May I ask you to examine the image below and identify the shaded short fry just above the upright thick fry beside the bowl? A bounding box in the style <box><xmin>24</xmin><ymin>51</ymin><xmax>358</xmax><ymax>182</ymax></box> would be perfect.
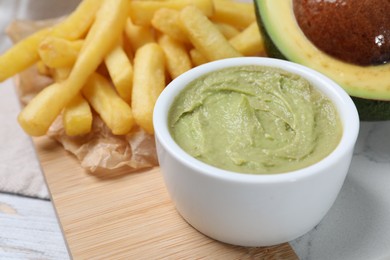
<box><xmin>125</xmin><ymin>17</ymin><xmax>155</xmax><ymax>52</ymax></box>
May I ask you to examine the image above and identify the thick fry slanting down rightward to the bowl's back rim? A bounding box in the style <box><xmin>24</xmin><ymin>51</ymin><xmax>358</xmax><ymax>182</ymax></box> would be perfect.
<box><xmin>180</xmin><ymin>5</ymin><xmax>242</xmax><ymax>61</ymax></box>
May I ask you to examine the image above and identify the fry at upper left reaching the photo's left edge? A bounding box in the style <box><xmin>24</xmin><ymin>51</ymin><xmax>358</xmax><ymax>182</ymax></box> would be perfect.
<box><xmin>0</xmin><ymin>0</ymin><xmax>103</xmax><ymax>82</ymax></box>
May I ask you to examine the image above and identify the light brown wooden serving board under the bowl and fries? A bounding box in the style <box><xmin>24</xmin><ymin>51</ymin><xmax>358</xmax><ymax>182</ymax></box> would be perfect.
<box><xmin>33</xmin><ymin>137</ymin><xmax>298</xmax><ymax>259</ymax></box>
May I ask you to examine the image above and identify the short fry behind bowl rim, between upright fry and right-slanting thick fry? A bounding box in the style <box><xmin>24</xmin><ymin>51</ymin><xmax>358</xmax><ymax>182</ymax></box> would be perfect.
<box><xmin>158</xmin><ymin>34</ymin><xmax>192</xmax><ymax>79</ymax></box>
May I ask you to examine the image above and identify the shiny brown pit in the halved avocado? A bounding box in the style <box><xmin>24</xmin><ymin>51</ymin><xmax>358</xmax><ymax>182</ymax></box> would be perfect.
<box><xmin>293</xmin><ymin>0</ymin><xmax>390</xmax><ymax>66</ymax></box>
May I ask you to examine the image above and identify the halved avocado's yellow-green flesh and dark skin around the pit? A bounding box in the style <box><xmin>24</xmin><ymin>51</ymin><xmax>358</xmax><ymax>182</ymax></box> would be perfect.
<box><xmin>254</xmin><ymin>0</ymin><xmax>390</xmax><ymax>121</ymax></box>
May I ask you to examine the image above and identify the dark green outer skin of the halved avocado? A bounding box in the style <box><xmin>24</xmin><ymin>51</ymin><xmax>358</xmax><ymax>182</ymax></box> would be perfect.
<box><xmin>254</xmin><ymin>0</ymin><xmax>390</xmax><ymax>121</ymax></box>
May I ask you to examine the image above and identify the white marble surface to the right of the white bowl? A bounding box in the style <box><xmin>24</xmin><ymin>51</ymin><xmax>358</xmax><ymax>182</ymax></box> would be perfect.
<box><xmin>291</xmin><ymin>121</ymin><xmax>390</xmax><ymax>260</ymax></box>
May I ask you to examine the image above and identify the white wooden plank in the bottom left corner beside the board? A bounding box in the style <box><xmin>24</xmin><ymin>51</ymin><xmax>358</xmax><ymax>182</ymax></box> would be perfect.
<box><xmin>0</xmin><ymin>193</ymin><xmax>70</xmax><ymax>260</ymax></box>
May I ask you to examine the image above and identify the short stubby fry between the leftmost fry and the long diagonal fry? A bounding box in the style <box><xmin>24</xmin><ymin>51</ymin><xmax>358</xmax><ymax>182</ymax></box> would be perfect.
<box><xmin>38</xmin><ymin>36</ymin><xmax>84</xmax><ymax>68</ymax></box>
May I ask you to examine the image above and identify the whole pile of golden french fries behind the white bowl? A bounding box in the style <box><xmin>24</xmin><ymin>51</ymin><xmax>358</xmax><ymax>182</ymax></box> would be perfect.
<box><xmin>0</xmin><ymin>0</ymin><xmax>264</xmax><ymax>136</ymax></box>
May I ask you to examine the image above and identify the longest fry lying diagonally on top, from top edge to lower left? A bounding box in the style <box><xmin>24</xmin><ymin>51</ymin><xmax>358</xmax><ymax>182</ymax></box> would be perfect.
<box><xmin>18</xmin><ymin>0</ymin><xmax>129</xmax><ymax>136</ymax></box>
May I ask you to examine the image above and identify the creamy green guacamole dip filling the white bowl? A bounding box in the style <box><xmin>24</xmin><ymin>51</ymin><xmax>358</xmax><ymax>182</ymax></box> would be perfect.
<box><xmin>168</xmin><ymin>66</ymin><xmax>342</xmax><ymax>174</ymax></box>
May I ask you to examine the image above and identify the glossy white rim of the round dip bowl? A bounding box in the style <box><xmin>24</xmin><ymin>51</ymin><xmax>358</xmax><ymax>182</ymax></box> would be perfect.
<box><xmin>153</xmin><ymin>57</ymin><xmax>360</xmax><ymax>183</ymax></box>
